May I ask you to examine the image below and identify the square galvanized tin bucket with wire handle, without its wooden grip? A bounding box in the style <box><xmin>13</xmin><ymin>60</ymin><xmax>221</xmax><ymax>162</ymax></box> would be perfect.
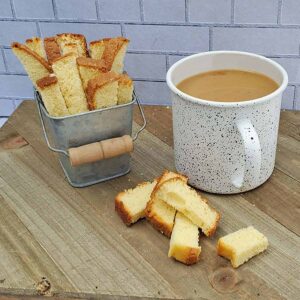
<box><xmin>35</xmin><ymin>91</ymin><xmax>146</xmax><ymax>187</ymax></box>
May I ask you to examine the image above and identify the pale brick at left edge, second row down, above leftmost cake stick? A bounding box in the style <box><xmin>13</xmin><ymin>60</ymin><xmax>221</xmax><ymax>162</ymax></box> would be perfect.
<box><xmin>0</xmin><ymin>21</ymin><xmax>37</xmax><ymax>46</ymax></box>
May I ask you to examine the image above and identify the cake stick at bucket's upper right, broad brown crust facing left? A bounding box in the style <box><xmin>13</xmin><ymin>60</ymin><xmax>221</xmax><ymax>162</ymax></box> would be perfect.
<box><xmin>102</xmin><ymin>37</ymin><xmax>129</xmax><ymax>73</ymax></box>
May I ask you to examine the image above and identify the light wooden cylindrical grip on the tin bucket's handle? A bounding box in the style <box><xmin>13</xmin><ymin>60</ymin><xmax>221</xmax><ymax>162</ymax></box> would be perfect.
<box><xmin>69</xmin><ymin>135</ymin><xmax>133</xmax><ymax>166</ymax></box>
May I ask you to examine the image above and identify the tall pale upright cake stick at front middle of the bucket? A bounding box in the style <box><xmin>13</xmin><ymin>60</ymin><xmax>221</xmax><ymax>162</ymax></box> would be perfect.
<box><xmin>52</xmin><ymin>53</ymin><xmax>88</xmax><ymax>114</ymax></box>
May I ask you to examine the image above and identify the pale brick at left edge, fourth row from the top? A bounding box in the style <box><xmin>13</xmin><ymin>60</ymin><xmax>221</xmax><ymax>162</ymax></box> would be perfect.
<box><xmin>0</xmin><ymin>75</ymin><xmax>33</xmax><ymax>99</ymax></box>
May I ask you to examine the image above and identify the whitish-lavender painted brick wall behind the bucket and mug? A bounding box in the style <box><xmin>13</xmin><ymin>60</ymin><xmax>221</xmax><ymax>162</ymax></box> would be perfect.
<box><xmin>0</xmin><ymin>0</ymin><xmax>300</xmax><ymax>122</ymax></box>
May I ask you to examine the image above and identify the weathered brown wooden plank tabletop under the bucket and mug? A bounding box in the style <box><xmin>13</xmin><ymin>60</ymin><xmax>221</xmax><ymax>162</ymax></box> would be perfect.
<box><xmin>0</xmin><ymin>101</ymin><xmax>300</xmax><ymax>299</ymax></box>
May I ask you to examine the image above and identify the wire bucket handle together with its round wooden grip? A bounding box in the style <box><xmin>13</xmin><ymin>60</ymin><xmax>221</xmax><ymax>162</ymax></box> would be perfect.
<box><xmin>35</xmin><ymin>90</ymin><xmax>147</xmax><ymax>166</ymax></box>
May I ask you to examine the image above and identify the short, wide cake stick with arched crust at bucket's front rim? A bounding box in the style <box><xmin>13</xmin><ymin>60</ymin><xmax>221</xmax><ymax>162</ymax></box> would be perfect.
<box><xmin>86</xmin><ymin>72</ymin><xmax>119</xmax><ymax>110</ymax></box>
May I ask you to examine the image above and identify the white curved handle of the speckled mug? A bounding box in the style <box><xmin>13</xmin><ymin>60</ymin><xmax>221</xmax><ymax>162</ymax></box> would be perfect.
<box><xmin>231</xmin><ymin>119</ymin><xmax>261</xmax><ymax>189</ymax></box>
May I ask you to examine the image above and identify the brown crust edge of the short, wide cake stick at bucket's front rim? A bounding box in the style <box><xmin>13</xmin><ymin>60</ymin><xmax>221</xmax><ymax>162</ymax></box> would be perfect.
<box><xmin>86</xmin><ymin>72</ymin><xmax>120</xmax><ymax>110</ymax></box>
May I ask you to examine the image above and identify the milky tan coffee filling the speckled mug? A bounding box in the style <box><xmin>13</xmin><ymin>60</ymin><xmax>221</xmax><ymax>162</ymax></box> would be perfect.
<box><xmin>177</xmin><ymin>70</ymin><xmax>278</xmax><ymax>102</ymax></box>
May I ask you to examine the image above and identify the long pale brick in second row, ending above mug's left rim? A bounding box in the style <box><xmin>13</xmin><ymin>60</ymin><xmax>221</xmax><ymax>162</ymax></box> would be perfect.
<box><xmin>125</xmin><ymin>25</ymin><xmax>208</xmax><ymax>53</ymax></box>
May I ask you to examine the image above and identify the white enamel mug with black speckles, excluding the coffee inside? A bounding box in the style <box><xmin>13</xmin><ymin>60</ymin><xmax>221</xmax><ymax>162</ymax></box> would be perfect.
<box><xmin>167</xmin><ymin>51</ymin><xmax>288</xmax><ymax>194</ymax></box>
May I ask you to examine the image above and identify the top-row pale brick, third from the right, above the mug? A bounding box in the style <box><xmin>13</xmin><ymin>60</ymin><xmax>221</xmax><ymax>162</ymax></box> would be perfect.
<box><xmin>189</xmin><ymin>0</ymin><xmax>231</xmax><ymax>23</ymax></box>
